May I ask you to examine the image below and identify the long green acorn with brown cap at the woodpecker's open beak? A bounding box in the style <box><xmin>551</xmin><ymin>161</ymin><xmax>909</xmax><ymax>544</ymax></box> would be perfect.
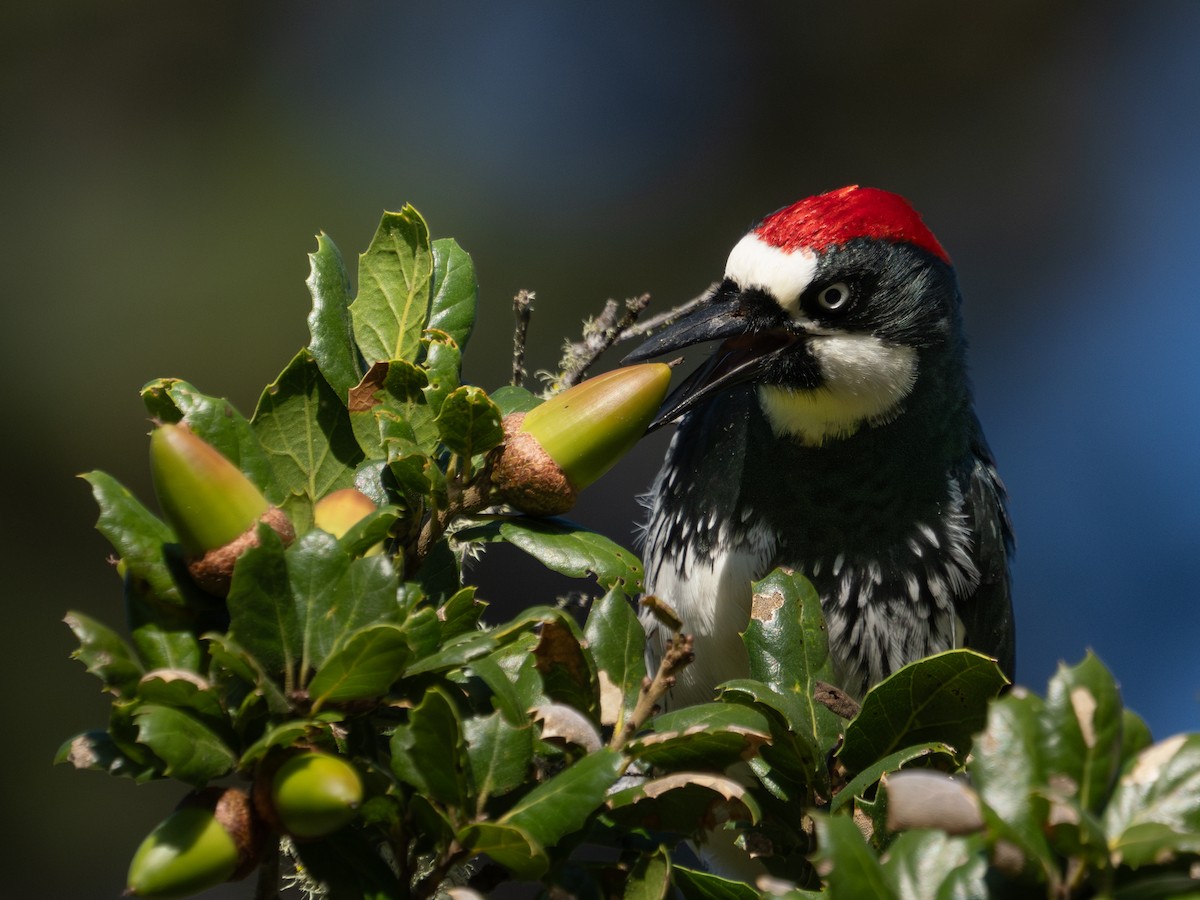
<box><xmin>492</xmin><ymin>362</ymin><xmax>671</xmax><ymax>516</ymax></box>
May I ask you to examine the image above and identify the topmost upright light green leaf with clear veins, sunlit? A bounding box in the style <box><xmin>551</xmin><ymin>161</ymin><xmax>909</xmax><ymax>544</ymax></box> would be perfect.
<box><xmin>350</xmin><ymin>205</ymin><xmax>433</xmax><ymax>365</ymax></box>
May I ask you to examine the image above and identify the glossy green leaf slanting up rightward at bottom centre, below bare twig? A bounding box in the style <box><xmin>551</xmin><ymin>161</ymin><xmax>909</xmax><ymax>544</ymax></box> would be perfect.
<box><xmin>498</xmin><ymin>748</ymin><xmax>624</xmax><ymax>847</ymax></box>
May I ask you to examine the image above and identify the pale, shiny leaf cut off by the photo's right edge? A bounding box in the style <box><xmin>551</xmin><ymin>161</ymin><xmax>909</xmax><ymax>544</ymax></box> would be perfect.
<box><xmin>1104</xmin><ymin>734</ymin><xmax>1200</xmax><ymax>866</ymax></box>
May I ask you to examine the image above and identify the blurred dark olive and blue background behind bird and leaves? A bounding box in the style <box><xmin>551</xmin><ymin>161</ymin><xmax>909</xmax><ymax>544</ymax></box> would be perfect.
<box><xmin>0</xmin><ymin>0</ymin><xmax>1200</xmax><ymax>900</ymax></box>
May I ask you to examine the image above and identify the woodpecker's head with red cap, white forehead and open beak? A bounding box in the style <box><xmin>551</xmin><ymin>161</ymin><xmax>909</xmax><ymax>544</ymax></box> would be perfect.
<box><xmin>625</xmin><ymin>186</ymin><xmax>962</xmax><ymax>444</ymax></box>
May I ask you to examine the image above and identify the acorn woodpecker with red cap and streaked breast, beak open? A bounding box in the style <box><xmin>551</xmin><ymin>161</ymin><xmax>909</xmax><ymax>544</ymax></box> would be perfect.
<box><xmin>625</xmin><ymin>186</ymin><xmax>1014</xmax><ymax>706</ymax></box>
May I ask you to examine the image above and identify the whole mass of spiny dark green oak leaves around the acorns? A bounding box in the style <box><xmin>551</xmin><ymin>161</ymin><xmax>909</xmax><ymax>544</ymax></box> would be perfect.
<box><xmin>59</xmin><ymin>208</ymin><xmax>1200</xmax><ymax>900</ymax></box>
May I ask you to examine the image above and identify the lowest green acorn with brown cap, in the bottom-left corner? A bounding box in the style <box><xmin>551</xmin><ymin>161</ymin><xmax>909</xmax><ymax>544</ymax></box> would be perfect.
<box><xmin>126</xmin><ymin>787</ymin><xmax>263</xmax><ymax>899</ymax></box>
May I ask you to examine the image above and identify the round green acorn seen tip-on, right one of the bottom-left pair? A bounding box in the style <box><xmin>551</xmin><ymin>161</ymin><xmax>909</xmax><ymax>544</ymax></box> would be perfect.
<box><xmin>262</xmin><ymin>750</ymin><xmax>362</xmax><ymax>840</ymax></box>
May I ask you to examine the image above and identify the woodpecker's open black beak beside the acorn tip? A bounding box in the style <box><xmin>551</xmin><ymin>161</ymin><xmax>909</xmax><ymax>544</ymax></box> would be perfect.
<box><xmin>622</xmin><ymin>290</ymin><xmax>803</xmax><ymax>431</ymax></box>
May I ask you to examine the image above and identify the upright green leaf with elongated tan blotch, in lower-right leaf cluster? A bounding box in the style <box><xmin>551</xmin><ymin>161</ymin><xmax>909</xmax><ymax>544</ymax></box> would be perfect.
<box><xmin>1044</xmin><ymin>652</ymin><xmax>1123</xmax><ymax>812</ymax></box>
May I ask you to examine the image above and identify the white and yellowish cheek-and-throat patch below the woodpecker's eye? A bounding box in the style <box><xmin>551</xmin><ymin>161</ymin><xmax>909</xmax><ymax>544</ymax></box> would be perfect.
<box><xmin>758</xmin><ymin>335</ymin><xmax>917</xmax><ymax>446</ymax></box>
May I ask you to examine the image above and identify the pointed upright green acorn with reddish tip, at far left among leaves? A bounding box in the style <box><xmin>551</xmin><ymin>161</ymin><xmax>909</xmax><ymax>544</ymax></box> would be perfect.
<box><xmin>150</xmin><ymin>425</ymin><xmax>295</xmax><ymax>596</ymax></box>
